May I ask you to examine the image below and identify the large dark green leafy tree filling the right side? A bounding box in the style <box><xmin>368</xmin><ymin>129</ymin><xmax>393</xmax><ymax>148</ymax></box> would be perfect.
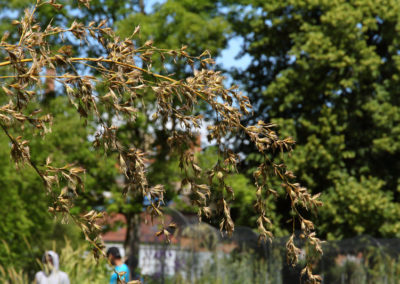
<box><xmin>225</xmin><ymin>0</ymin><xmax>400</xmax><ymax>238</ymax></box>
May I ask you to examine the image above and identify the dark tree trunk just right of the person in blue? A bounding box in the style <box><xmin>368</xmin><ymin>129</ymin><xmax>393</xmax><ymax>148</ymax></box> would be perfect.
<box><xmin>124</xmin><ymin>213</ymin><xmax>140</xmax><ymax>279</ymax></box>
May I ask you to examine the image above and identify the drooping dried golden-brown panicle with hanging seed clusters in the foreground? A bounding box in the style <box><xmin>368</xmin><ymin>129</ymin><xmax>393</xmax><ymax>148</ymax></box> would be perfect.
<box><xmin>0</xmin><ymin>0</ymin><xmax>321</xmax><ymax>280</ymax></box>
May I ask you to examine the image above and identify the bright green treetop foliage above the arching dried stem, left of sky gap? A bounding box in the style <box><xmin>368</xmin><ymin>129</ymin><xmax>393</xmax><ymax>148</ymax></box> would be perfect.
<box><xmin>117</xmin><ymin>0</ymin><xmax>229</xmax><ymax>72</ymax></box>
